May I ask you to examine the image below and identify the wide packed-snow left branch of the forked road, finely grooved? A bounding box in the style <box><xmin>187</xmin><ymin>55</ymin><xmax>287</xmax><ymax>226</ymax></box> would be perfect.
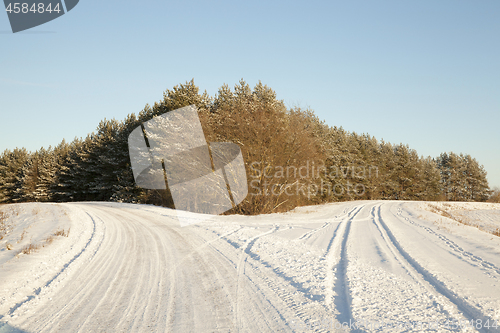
<box><xmin>8</xmin><ymin>205</ymin><xmax>240</xmax><ymax>332</ymax></box>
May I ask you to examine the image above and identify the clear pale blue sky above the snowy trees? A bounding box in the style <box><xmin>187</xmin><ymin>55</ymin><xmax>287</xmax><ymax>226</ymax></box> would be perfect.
<box><xmin>0</xmin><ymin>0</ymin><xmax>500</xmax><ymax>187</ymax></box>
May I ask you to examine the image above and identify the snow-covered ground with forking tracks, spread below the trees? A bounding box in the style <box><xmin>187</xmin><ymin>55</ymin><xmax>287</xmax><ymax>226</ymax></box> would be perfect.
<box><xmin>0</xmin><ymin>201</ymin><xmax>500</xmax><ymax>332</ymax></box>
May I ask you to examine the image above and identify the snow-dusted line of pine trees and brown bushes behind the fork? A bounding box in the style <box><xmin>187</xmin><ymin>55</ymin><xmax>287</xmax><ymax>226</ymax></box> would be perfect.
<box><xmin>0</xmin><ymin>80</ymin><xmax>492</xmax><ymax>214</ymax></box>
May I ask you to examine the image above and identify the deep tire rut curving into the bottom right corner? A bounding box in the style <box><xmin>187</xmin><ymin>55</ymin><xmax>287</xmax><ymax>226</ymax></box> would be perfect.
<box><xmin>373</xmin><ymin>205</ymin><xmax>498</xmax><ymax>332</ymax></box>
